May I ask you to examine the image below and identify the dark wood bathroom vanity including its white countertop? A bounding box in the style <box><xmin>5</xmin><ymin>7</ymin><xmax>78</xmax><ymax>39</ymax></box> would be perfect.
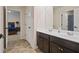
<box><xmin>37</xmin><ymin>30</ymin><xmax>79</xmax><ymax>53</ymax></box>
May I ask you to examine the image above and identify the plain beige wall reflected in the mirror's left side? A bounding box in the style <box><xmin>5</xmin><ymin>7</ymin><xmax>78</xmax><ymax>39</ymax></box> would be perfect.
<box><xmin>53</xmin><ymin>7</ymin><xmax>61</xmax><ymax>29</ymax></box>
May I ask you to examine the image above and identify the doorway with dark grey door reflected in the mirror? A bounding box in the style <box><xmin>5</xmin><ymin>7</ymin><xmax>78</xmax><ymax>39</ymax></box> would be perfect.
<box><xmin>61</xmin><ymin>10</ymin><xmax>74</xmax><ymax>31</ymax></box>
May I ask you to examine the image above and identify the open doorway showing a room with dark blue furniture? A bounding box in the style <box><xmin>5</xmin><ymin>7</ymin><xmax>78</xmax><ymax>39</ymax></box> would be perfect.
<box><xmin>5</xmin><ymin>7</ymin><xmax>21</xmax><ymax>48</ymax></box>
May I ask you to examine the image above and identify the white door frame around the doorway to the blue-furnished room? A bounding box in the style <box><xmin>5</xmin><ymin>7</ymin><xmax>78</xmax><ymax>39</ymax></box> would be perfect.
<box><xmin>6</xmin><ymin>6</ymin><xmax>22</xmax><ymax>48</ymax></box>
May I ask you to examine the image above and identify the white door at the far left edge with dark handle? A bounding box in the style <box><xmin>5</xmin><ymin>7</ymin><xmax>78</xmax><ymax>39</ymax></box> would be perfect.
<box><xmin>0</xmin><ymin>7</ymin><xmax>4</xmax><ymax>53</ymax></box>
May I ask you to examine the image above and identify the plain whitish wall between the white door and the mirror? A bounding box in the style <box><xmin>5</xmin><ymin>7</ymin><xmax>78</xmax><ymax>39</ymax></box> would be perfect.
<box><xmin>34</xmin><ymin>6</ymin><xmax>53</xmax><ymax>29</ymax></box>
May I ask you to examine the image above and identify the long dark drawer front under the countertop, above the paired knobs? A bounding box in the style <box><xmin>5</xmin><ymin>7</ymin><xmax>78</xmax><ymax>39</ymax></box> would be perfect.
<box><xmin>50</xmin><ymin>36</ymin><xmax>79</xmax><ymax>52</ymax></box>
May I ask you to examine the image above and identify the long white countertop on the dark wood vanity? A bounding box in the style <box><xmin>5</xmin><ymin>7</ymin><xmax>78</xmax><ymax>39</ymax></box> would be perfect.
<box><xmin>37</xmin><ymin>28</ymin><xmax>79</xmax><ymax>43</ymax></box>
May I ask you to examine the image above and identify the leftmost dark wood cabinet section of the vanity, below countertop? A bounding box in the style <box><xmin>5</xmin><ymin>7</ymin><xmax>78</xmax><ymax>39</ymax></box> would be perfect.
<box><xmin>37</xmin><ymin>32</ymin><xmax>49</xmax><ymax>53</ymax></box>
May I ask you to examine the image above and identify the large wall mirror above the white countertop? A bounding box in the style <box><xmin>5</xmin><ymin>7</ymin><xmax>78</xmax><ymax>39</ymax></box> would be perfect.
<box><xmin>53</xmin><ymin>6</ymin><xmax>79</xmax><ymax>31</ymax></box>
